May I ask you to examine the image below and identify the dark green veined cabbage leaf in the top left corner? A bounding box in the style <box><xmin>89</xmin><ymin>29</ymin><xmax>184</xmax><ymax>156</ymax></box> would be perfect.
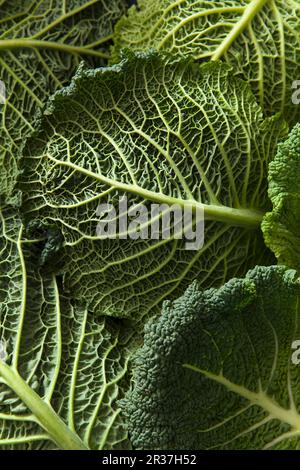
<box><xmin>0</xmin><ymin>0</ymin><xmax>126</xmax><ymax>197</ymax></box>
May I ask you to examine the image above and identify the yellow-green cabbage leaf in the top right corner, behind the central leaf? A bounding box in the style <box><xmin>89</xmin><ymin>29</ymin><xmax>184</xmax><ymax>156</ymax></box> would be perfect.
<box><xmin>113</xmin><ymin>0</ymin><xmax>300</xmax><ymax>123</ymax></box>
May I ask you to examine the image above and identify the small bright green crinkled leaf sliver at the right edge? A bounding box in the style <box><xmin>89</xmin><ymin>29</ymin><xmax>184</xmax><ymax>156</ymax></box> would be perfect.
<box><xmin>262</xmin><ymin>124</ymin><xmax>300</xmax><ymax>272</ymax></box>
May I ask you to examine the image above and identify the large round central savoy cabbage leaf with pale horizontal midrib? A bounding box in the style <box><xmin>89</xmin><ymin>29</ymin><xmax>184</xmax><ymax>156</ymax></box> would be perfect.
<box><xmin>20</xmin><ymin>54</ymin><xmax>286</xmax><ymax>317</ymax></box>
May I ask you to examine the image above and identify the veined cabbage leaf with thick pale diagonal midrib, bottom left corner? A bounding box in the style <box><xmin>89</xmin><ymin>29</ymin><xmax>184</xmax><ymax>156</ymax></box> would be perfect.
<box><xmin>0</xmin><ymin>208</ymin><xmax>133</xmax><ymax>450</ymax></box>
